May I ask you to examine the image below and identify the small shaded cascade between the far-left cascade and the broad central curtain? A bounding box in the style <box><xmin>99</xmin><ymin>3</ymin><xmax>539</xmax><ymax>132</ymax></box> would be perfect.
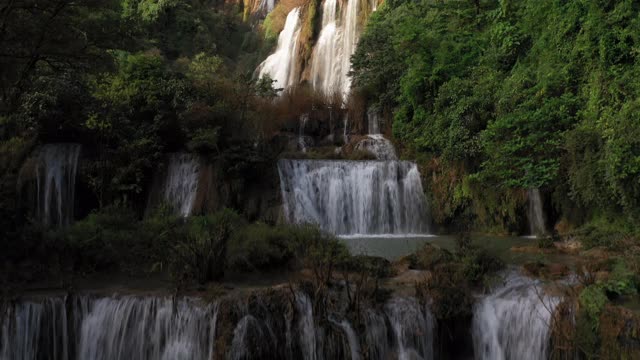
<box><xmin>162</xmin><ymin>153</ymin><xmax>200</xmax><ymax>217</ymax></box>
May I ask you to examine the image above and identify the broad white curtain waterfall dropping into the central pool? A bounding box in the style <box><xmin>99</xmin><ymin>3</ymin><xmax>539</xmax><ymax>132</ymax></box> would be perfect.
<box><xmin>278</xmin><ymin>160</ymin><xmax>428</xmax><ymax>235</ymax></box>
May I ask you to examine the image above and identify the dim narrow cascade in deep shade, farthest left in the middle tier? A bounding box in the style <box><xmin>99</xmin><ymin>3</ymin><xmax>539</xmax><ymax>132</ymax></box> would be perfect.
<box><xmin>28</xmin><ymin>144</ymin><xmax>80</xmax><ymax>226</ymax></box>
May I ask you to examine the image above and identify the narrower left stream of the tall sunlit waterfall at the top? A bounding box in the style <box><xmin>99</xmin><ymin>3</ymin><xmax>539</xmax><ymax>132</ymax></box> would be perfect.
<box><xmin>258</xmin><ymin>8</ymin><xmax>300</xmax><ymax>89</ymax></box>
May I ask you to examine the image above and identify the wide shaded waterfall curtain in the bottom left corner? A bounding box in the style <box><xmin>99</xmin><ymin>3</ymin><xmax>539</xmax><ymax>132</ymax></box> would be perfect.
<box><xmin>0</xmin><ymin>296</ymin><xmax>217</xmax><ymax>360</ymax></box>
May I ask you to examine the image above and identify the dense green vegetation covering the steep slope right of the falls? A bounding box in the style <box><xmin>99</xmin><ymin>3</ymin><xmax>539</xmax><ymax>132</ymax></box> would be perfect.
<box><xmin>353</xmin><ymin>0</ymin><xmax>640</xmax><ymax>234</ymax></box>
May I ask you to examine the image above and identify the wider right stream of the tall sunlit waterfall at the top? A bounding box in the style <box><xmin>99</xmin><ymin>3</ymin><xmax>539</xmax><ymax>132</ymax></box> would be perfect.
<box><xmin>311</xmin><ymin>0</ymin><xmax>360</xmax><ymax>98</ymax></box>
